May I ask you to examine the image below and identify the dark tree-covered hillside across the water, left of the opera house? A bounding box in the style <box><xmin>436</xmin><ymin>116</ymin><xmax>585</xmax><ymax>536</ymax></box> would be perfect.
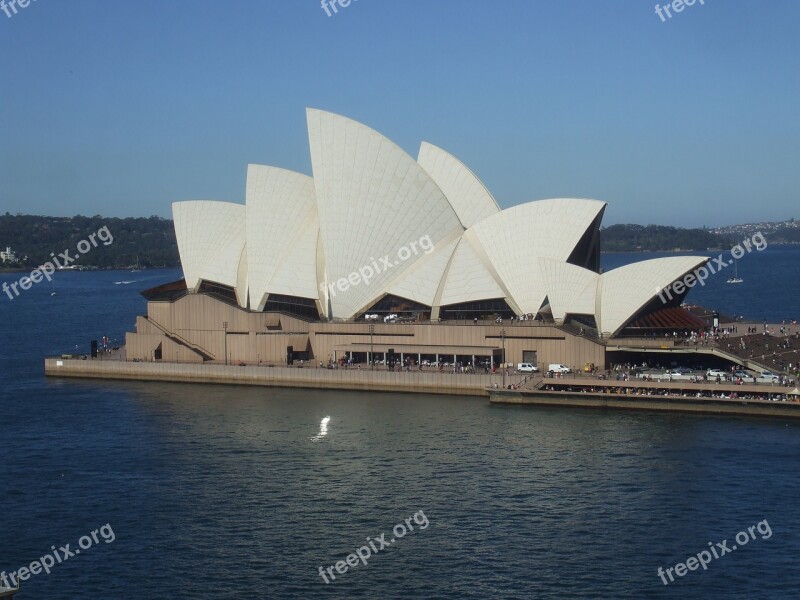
<box><xmin>0</xmin><ymin>213</ymin><xmax>180</xmax><ymax>268</ymax></box>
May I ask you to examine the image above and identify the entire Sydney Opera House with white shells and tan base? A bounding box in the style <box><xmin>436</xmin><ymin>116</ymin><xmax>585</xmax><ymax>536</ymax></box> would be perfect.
<box><xmin>126</xmin><ymin>109</ymin><xmax>708</xmax><ymax>368</ymax></box>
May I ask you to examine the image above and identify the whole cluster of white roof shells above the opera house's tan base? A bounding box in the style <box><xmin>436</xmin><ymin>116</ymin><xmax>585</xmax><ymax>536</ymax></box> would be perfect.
<box><xmin>166</xmin><ymin>109</ymin><xmax>708</xmax><ymax>337</ymax></box>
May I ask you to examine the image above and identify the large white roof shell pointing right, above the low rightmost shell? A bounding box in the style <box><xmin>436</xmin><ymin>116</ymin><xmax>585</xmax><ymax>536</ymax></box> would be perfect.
<box><xmin>470</xmin><ymin>198</ymin><xmax>605</xmax><ymax>313</ymax></box>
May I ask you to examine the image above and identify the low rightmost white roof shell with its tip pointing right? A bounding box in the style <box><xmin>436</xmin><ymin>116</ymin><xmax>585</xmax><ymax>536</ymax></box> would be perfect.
<box><xmin>595</xmin><ymin>256</ymin><xmax>708</xmax><ymax>336</ymax></box>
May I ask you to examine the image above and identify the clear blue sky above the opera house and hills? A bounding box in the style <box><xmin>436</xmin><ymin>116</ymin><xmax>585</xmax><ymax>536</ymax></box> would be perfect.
<box><xmin>0</xmin><ymin>0</ymin><xmax>800</xmax><ymax>227</ymax></box>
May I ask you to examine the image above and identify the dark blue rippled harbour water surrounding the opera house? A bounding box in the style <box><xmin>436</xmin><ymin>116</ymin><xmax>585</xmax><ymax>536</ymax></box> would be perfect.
<box><xmin>0</xmin><ymin>248</ymin><xmax>800</xmax><ymax>600</ymax></box>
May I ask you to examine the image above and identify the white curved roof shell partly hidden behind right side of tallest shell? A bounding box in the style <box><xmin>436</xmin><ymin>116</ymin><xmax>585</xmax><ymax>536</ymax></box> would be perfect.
<box><xmin>417</xmin><ymin>142</ymin><xmax>500</xmax><ymax>228</ymax></box>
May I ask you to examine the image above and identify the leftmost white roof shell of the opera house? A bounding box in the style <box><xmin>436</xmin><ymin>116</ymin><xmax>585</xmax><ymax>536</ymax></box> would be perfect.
<box><xmin>172</xmin><ymin>200</ymin><xmax>246</xmax><ymax>294</ymax></box>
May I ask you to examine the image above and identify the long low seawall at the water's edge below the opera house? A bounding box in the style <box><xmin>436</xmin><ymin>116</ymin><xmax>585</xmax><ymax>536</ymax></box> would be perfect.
<box><xmin>44</xmin><ymin>357</ymin><xmax>800</xmax><ymax>418</ymax></box>
